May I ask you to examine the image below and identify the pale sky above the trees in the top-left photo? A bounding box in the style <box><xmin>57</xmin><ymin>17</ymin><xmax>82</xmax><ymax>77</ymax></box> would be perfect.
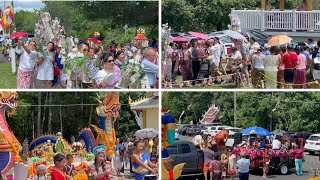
<box><xmin>0</xmin><ymin>0</ymin><xmax>44</xmax><ymax>12</ymax></box>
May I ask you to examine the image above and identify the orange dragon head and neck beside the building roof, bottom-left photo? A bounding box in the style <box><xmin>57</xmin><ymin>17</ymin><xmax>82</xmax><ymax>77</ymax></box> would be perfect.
<box><xmin>91</xmin><ymin>92</ymin><xmax>121</xmax><ymax>156</ymax></box>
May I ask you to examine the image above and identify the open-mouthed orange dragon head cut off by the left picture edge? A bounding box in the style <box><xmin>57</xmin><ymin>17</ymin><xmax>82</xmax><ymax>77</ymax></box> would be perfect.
<box><xmin>0</xmin><ymin>91</ymin><xmax>18</xmax><ymax>116</ymax></box>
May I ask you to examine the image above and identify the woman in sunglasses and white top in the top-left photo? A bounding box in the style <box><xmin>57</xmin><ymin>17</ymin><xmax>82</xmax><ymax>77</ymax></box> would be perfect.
<box><xmin>96</xmin><ymin>53</ymin><xmax>121</xmax><ymax>89</ymax></box>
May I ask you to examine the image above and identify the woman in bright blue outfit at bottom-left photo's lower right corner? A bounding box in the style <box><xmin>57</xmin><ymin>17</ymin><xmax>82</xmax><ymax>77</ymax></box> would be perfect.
<box><xmin>132</xmin><ymin>141</ymin><xmax>158</xmax><ymax>180</ymax></box>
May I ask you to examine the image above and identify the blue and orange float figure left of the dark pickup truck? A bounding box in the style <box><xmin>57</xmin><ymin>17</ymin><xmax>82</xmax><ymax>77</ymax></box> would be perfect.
<box><xmin>161</xmin><ymin>109</ymin><xmax>185</xmax><ymax>180</ymax></box>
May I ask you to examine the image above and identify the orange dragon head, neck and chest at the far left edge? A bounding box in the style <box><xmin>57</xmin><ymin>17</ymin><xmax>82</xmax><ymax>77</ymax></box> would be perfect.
<box><xmin>0</xmin><ymin>92</ymin><xmax>21</xmax><ymax>174</ymax></box>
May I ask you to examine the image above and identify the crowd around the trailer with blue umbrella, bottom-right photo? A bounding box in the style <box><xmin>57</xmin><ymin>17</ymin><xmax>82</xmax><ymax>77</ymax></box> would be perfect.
<box><xmin>192</xmin><ymin>130</ymin><xmax>305</xmax><ymax>180</ymax></box>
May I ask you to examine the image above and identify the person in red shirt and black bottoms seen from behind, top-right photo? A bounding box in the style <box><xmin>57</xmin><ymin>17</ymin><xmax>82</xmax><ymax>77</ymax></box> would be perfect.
<box><xmin>282</xmin><ymin>45</ymin><xmax>298</xmax><ymax>89</ymax></box>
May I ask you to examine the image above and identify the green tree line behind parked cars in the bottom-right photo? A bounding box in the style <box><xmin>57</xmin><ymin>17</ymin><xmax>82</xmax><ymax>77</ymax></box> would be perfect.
<box><xmin>162</xmin><ymin>92</ymin><xmax>320</xmax><ymax>132</ymax></box>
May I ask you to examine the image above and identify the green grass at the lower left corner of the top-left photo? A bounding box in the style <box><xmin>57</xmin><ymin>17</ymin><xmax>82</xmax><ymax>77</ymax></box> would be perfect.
<box><xmin>0</xmin><ymin>62</ymin><xmax>16</xmax><ymax>89</ymax></box>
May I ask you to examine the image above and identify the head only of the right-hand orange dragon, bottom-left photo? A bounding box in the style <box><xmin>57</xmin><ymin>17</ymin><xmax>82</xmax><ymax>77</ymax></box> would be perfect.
<box><xmin>97</xmin><ymin>92</ymin><xmax>121</xmax><ymax>118</ymax></box>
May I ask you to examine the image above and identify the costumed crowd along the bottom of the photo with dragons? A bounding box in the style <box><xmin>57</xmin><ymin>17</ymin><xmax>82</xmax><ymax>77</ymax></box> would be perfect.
<box><xmin>1</xmin><ymin>137</ymin><xmax>159</xmax><ymax>180</ymax></box>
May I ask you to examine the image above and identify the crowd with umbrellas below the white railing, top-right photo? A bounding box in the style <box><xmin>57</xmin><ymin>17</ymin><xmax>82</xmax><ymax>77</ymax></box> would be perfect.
<box><xmin>162</xmin><ymin>34</ymin><xmax>320</xmax><ymax>89</ymax></box>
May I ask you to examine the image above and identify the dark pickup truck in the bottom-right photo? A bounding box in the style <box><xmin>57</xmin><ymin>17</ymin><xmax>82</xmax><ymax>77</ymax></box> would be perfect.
<box><xmin>167</xmin><ymin>140</ymin><xmax>204</xmax><ymax>179</ymax></box>
